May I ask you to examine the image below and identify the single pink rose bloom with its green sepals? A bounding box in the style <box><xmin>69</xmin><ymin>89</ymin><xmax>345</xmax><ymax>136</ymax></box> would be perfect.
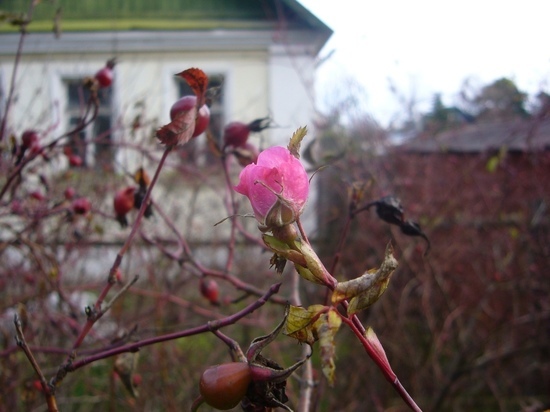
<box><xmin>235</xmin><ymin>146</ymin><xmax>309</xmax><ymax>231</ymax></box>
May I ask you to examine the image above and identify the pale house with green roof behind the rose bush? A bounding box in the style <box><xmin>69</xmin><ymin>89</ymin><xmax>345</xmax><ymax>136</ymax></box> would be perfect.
<box><xmin>0</xmin><ymin>0</ymin><xmax>332</xmax><ymax>166</ymax></box>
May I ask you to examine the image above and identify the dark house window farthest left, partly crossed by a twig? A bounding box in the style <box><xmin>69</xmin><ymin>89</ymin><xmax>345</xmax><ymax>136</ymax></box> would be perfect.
<box><xmin>64</xmin><ymin>79</ymin><xmax>114</xmax><ymax>169</ymax></box>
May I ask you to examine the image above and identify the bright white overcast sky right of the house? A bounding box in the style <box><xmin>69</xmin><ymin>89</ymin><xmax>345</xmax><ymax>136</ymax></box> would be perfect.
<box><xmin>300</xmin><ymin>0</ymin><xmax>550</xmax><ymax>124</ymax></box>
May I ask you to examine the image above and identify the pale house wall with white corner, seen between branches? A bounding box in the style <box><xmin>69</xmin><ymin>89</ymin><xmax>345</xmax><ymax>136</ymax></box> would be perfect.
<box><xmin>0</xmin><ymin>33</ymin><xmax>322</xmax><ymax>242</ymax></box>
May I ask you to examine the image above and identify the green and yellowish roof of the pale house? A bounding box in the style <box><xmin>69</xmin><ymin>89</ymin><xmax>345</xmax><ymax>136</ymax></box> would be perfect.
<box><xmin>0</xmin><ymin>0</ymin><xmax>330</xmax><ymax>31</ymax></box>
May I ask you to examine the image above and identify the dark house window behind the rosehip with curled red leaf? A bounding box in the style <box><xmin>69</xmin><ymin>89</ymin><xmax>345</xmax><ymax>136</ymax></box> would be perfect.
<box><xmin>176</xmin><ymin>73</ymin><xmax>225</xmax><ymax>164</ymax></box>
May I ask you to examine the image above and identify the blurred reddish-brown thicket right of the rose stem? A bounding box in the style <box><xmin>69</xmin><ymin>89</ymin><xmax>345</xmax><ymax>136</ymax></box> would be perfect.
<box><xmin>318</xmin><ymin>85</ymin><xmax>550</xmax><ymax>411</ymax></box>
